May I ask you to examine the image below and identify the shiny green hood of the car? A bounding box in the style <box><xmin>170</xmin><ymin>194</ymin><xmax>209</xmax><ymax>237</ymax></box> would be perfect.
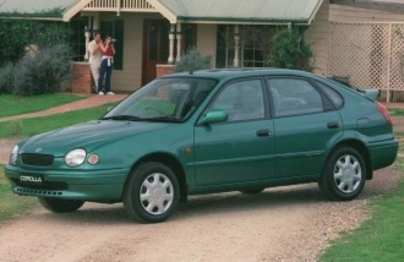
<box><xmin>20</xmin><ymin>120</ymin><xmax>169</xmax><ymax>157</ymax></box>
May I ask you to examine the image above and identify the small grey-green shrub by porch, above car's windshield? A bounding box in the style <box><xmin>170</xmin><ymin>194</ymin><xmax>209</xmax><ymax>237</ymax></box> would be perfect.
<box><xmin>176</xmin><ymin>48</ymin><xmax>210</xmax><ymax>72</ymax></box>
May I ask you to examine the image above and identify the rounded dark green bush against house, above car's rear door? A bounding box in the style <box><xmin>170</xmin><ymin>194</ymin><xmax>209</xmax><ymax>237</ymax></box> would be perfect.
<box><xmin>267</xmin><ymin>29</ymin><xmax>313</xmax><ymax>71</ymax></box>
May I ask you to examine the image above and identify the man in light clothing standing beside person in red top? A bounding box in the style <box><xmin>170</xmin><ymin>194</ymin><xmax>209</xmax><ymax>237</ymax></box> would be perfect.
<box><xmin>88</xmin><ymin>32</ymin><xmax>102</xmax><ymax>93</ymax></box>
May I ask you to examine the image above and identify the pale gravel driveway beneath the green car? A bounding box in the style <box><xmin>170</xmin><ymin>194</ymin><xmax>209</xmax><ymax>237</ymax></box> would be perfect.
<box><xmin>0</xmin><ymin>169</ymin><xmax>398</xmax><ymax>262</ymax></box>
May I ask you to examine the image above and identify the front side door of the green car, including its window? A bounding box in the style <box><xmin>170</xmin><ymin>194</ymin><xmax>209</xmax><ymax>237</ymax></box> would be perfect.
<box><xmin>194</xmin><ymin>79</ymin><xmax>274</xmax><ymax>189</ymax></box>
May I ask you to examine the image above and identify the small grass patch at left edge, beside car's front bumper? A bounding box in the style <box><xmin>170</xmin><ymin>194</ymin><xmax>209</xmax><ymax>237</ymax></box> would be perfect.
<box><xmin>0</xmin><ymin>166</ymin><xmax>37</xmax><ymax>223</ymax></box>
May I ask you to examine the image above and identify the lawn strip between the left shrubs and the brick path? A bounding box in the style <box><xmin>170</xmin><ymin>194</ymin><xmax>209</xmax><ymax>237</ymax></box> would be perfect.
<box><xmin>0</xmin><ymin>93</ymin><xmax>84</xmax><ymax>117</ymax></box>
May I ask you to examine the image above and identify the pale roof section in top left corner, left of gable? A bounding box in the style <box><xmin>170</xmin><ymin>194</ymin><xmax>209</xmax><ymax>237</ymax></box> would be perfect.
<box><xmin>0</xmin><ymin>0</ymin><xmax>76</xmax><ymax>20</ymax></box>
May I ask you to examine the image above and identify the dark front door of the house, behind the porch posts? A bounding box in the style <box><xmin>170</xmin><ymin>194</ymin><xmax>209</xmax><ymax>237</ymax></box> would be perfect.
<box><xmin>142</xmin><ymin>19</ymin><xmax>170</xmax><ymax>84</ymax></box>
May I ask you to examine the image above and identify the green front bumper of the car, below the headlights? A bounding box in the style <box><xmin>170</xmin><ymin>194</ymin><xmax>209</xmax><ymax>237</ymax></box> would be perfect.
<box><xmin>5</xmin><ymin>165</ymin><xmax>129</xmax><ymax>203</ymax></box>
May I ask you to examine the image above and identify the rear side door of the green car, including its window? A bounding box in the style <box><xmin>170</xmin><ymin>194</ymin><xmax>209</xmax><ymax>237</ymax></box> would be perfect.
<box><xmin>267</xmin><ymin>77</ymin><xmax>342</xmax><ymax>179</ymax></box>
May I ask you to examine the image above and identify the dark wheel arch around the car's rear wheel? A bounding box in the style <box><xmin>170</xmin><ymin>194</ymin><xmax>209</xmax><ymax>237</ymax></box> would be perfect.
<box><xmin>322</xmin><ymin>138</ymin><xmax>373</xmax><ymax>180</ymax></box>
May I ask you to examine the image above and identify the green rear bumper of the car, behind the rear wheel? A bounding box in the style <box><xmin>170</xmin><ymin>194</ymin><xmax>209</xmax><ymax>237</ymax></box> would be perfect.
<box><xmin>369</xmin><ymin>140</ymin><xmax>399</xmax><ymax>170</ymax></box>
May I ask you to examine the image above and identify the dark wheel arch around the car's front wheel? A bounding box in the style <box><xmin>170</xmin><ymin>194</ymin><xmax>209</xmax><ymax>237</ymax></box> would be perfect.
<box><xmin>122</xmin><ymin>152</ymin><xmax>188</xmax><ymax>201</ymax></box>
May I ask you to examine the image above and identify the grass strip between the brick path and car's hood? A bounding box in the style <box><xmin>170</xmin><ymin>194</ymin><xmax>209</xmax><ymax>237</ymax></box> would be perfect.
<box><xmin>0</xmin><ymin>105</ymin><xmax>112</xmax><ymax>138</ymax></box>
